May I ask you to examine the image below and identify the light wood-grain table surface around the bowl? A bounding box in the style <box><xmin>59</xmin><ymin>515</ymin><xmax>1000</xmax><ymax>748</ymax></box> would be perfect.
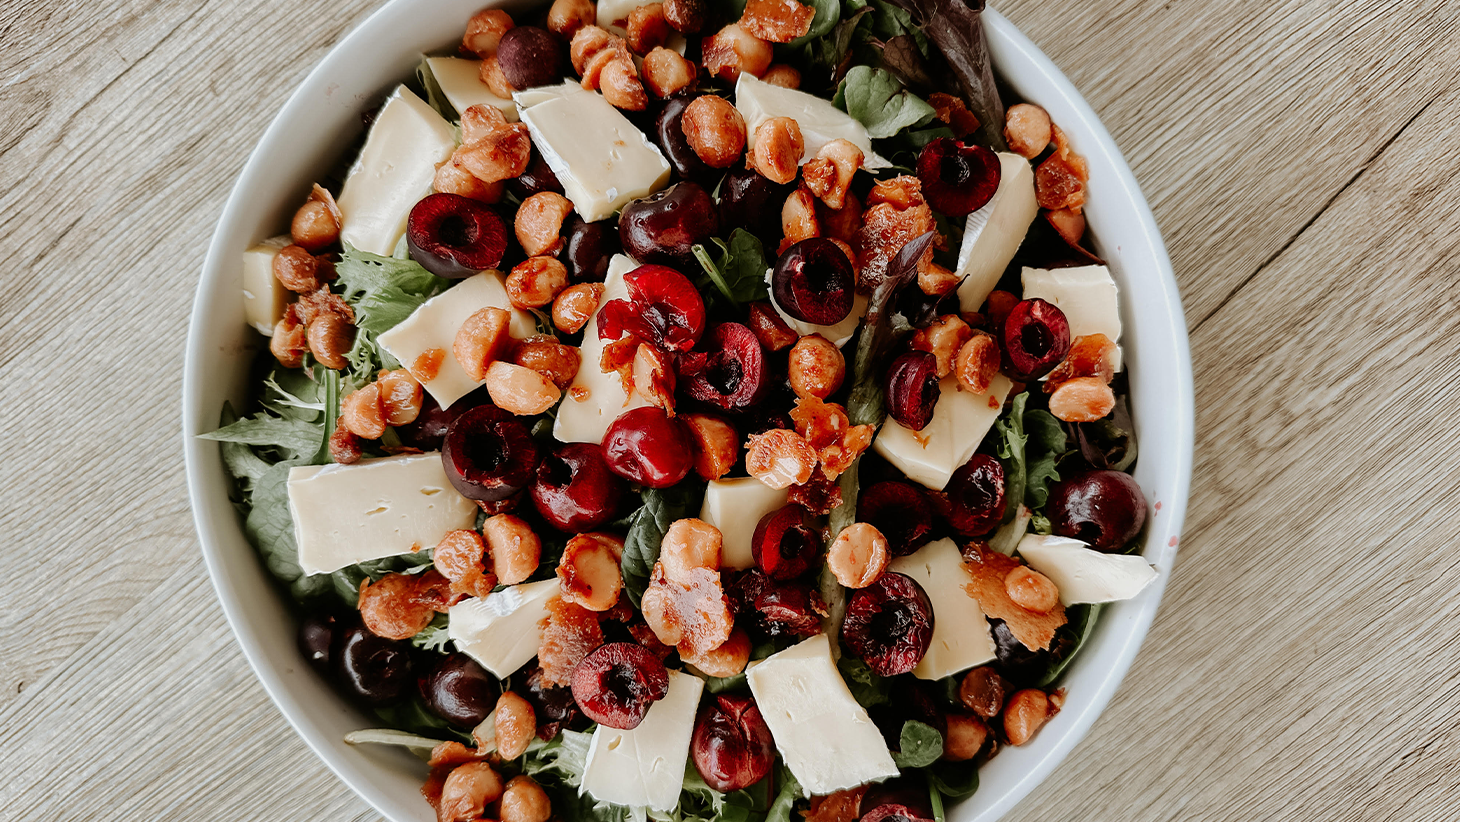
<box><xmin>0</xmin><ymin>0</ymin><xmax>1460</xmax><ymax>822</ymax></box>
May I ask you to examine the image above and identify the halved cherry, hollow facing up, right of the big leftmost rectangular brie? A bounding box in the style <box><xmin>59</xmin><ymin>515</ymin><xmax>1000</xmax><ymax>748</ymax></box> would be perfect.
<box><xmin>441</xmin><ymin>404</ymin><xmax>539</xmax><ymax>502</ymax></box>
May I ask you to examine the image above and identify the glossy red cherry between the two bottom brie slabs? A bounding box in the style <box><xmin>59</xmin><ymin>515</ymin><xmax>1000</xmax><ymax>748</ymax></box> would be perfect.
<box><xmin>689</xmin><ymin>694</ymin><xmax>775</xmax><ymax>791</ymax></box>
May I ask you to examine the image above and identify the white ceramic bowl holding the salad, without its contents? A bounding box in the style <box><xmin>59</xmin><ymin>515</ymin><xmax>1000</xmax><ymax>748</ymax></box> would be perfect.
<box><xmin>183</xmin><ymin>0</ymin><xmax>1193</xmax><ymax>822</ymax></box>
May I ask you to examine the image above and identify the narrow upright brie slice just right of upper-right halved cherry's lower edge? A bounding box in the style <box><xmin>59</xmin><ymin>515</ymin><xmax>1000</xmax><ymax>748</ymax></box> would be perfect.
<box><xmin>956</xmin><ymin>152</ymin><xmax>1040</xmax><ymax>311</ymax></box>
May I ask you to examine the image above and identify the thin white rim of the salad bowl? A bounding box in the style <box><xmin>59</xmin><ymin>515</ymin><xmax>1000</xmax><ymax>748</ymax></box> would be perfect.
<box><xmin>181</xmin><ymin>0</ymin><xmax>1194</xmax><ymax>822</ymax></box>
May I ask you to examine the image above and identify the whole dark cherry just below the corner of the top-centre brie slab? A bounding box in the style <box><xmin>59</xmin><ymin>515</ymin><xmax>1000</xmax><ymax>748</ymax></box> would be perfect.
<box><xmin>619</xmin><ymin>181</ymin><xmax>720</xmax><ymax>266</ymax></box>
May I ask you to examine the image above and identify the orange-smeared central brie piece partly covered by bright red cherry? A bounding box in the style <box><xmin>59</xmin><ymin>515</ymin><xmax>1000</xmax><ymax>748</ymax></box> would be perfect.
<box><xmin>552</xmin><ymin>254</ymin><xmax>648</xmax><ymax>442</ymax></box>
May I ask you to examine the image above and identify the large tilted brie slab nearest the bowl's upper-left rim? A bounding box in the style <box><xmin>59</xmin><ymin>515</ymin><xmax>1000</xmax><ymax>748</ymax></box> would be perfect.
<box><xmin>339</xmin><ymin>86</ymin><xmax>456</xmax><ymax>257</ymax></box>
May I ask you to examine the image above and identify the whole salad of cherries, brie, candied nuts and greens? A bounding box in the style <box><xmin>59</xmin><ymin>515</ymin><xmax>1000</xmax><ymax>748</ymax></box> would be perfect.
<box><xmin>206</xmin><ymin>0</ymin><xmax>1155</xmax><ymax>822</ymax></box>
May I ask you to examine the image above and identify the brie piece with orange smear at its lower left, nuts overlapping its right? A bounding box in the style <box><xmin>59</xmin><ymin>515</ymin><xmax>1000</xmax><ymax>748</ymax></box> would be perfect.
<box><xmin>378</xmin><ymin>272</ymin><xmax>537</xmax><ymax>407</ymax></box>
